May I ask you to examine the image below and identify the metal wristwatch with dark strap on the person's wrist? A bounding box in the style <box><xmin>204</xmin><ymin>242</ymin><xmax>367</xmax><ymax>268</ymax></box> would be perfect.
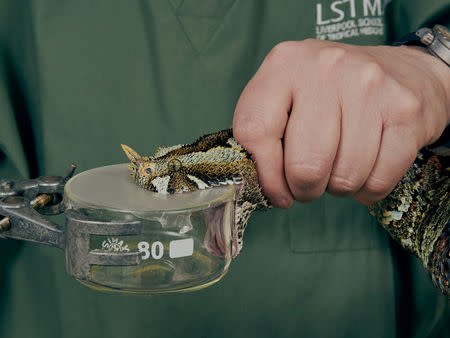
<box><xmin>393</xmin><ymin>25</ymin><xmax>450</xmax><ymax>67</ymax></box>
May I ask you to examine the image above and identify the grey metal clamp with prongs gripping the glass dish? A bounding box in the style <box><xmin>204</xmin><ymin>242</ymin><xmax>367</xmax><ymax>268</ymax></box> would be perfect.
<box><xmin>0</xmin><ymin>165</ymin><xmax>142</xmax><ymax>281</ymax></box>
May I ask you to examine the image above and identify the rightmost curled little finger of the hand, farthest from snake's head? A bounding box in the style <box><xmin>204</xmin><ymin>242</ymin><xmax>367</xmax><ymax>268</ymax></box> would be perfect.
<box><xmin>353</xmin><ymin>127</ymin><xmax>417</xmax><ymax>205</ymax></box>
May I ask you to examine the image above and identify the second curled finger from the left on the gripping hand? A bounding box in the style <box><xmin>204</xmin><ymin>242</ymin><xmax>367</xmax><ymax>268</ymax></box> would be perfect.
<box><xmin>284</xmin><ymin>88</ymin><xmax>341</xmax><ymax>202</ymax></box>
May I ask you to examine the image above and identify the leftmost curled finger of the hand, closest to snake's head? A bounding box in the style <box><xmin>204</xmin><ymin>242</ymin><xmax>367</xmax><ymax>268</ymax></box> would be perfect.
<box><xmin>233</xmin><ymin>52</ymin><xmax>293</xmax><ymax>208</ymax></box>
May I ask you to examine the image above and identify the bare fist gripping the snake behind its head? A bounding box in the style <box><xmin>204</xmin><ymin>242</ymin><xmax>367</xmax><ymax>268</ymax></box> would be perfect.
<box><xmin>233</xmin><ymin>40</ymin><xmax>450</xmax><ymax>208</ymax></box>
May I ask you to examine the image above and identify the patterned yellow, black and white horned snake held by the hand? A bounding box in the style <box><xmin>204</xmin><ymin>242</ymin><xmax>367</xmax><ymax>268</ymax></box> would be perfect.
<box><xmin>122</xmin><ymin>129</ymin><xmax>450</xmax><ymax>296</ymax></box>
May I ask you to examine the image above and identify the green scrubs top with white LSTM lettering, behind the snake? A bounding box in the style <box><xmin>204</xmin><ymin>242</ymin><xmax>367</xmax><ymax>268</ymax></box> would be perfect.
<box><xmin>0</xmin><ymin>0</ymin><xmax>450</xmax><ymax>338</ymax></box>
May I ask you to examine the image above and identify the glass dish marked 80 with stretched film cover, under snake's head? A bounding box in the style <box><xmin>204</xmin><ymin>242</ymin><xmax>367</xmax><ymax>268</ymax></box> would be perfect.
<box><xmin>64</xmin><ymin>164</ymin><xmax>239</xmax><ymax>293</ymax></box>
